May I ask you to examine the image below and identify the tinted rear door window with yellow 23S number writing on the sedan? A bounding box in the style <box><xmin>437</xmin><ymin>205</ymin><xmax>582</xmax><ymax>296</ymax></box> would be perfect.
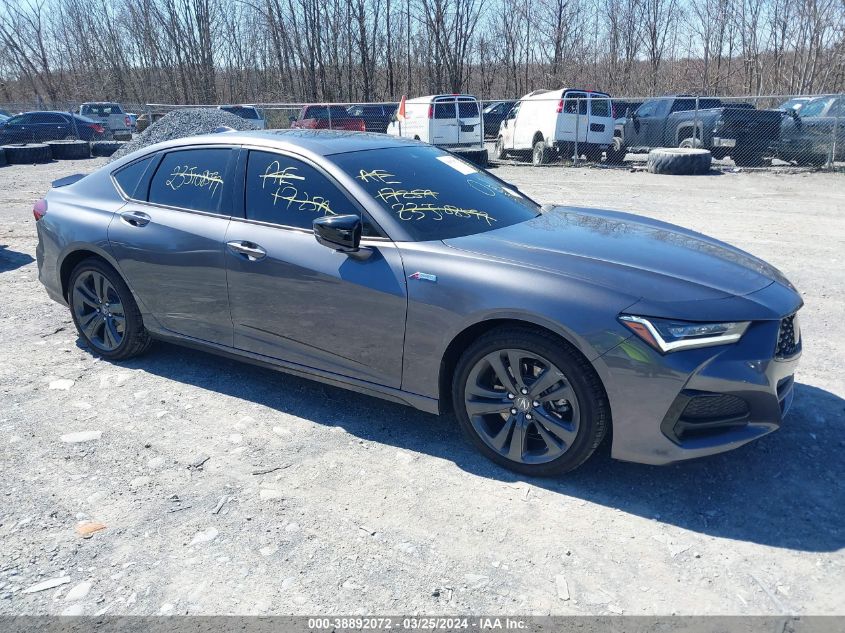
<box><xmin>149</xmin><ymin>148</ymin><xmax>232</xmax><ymax>213</ymax></box>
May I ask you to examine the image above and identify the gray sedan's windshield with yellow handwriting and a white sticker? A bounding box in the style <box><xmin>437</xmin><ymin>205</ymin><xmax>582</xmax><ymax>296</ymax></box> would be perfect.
<box><xmin>332</xmin><ymin>145</ymin><xmax>540</xmax><ymax>242</ymax></box>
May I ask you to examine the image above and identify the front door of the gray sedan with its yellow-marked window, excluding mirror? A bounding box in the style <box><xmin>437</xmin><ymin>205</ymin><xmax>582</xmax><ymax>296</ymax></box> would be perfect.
<box><xmin>225</xmin><ymin>150</ymin><xmax>407</xmax><ymax>387</ymax></box>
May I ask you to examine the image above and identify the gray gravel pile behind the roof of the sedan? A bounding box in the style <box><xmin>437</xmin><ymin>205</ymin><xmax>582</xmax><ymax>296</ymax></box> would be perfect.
<box><xmin>111</xmin><ymin>108</ymin><xmax>258</xmax><ymax>160</ymax></box>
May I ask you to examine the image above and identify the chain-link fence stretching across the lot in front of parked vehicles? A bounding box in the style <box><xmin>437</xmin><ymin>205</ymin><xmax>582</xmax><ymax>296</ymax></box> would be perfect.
<box><xmin>0</xmin><ymin>90</ymin><xmax>845</xmax><ymax>169</ymax></box>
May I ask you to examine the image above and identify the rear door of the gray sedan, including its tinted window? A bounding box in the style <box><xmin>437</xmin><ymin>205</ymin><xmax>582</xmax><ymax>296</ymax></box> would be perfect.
<box><xmin>108</xmin><ymin>146</ymin><xmax>237</xmax><ymax>346</ymax></box>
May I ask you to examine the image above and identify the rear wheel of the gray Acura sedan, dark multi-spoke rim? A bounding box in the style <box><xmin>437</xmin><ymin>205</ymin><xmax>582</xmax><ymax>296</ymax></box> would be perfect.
<box><xmin>68</xmin><ymin>258</ymin><xmax>151</xmax><ymax>360</ymax></box>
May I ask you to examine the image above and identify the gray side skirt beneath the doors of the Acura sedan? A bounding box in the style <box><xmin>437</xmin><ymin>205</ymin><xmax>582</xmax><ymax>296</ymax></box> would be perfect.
<box><xmin>150</xmin><ymin>331</ymin><xmax>440</xmax><ymax>415</ymax></box>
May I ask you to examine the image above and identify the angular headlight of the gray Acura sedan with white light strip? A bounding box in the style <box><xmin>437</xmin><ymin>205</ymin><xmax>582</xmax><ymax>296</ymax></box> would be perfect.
<box><xmin>619</xmin><ymin>314</ymin><xmax>751</xmax><ymax>354</ymax></box>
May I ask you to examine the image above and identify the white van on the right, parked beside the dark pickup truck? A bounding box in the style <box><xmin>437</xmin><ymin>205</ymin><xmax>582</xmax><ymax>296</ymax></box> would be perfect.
<box><xmin>495</xmin><ymin>88</ymin><xmax>616</xmax><ymax>165</ymax></box>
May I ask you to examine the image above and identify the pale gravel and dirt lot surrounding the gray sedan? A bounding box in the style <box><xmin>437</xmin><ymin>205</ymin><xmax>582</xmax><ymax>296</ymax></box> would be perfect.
<box><xmin>0</xmin><ymin>161</ymin><xmax>845</xmax><ymax>614</ymax></box>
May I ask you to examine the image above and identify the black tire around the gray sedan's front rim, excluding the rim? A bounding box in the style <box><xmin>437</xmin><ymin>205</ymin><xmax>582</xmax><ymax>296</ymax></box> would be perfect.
<box><xmin>452</xmin><ymin>331</ymin><xmax>603</xmax><ymax>477</ymax></box>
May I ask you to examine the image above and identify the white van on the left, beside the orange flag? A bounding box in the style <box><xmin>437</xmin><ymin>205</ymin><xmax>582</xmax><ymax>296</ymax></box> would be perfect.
<box><xmin>387</xmin><ymin>95</ymin><xmax>487</xmax><ymax>165</ymax></box>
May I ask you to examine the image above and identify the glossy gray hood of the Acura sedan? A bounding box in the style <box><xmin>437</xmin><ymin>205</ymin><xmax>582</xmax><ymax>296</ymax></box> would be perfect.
<box><xmin>445</xmin><ymin>207</ymin><xmax>792</xmax><ymax>302</ymax></box>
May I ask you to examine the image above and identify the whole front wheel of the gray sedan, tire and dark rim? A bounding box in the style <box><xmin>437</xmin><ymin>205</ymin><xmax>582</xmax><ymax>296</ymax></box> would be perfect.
<box><xmin>452</xmin><ymin>328</ymin><xmax>610</xmax><ymax>477</ymax></box>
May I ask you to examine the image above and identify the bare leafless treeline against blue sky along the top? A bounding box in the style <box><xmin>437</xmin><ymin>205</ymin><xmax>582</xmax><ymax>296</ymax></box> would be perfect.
<box><xmin>0</xmin><ymin>0</ymin><xmax>845</xmax><ymax>105</ymax></box>
